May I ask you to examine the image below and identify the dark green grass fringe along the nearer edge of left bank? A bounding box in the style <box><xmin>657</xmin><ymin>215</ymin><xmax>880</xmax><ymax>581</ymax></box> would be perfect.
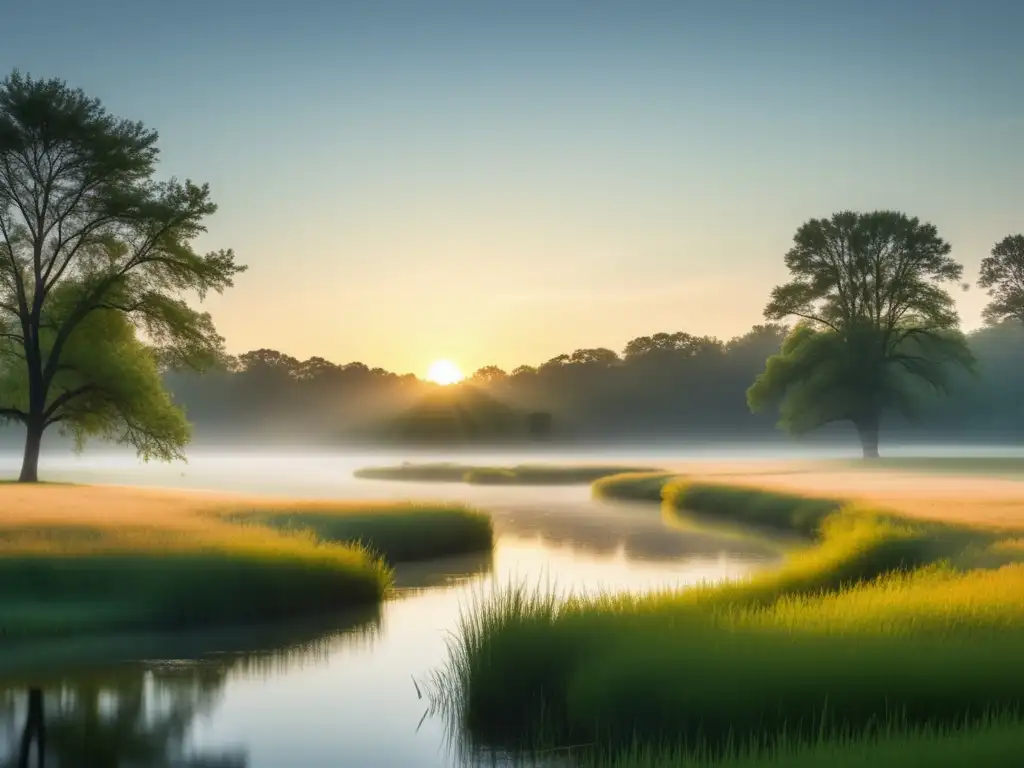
<box><xmin>0</xmin><ymin>544</ymin><xmax>392</xmax><ymax>644</ymax></box>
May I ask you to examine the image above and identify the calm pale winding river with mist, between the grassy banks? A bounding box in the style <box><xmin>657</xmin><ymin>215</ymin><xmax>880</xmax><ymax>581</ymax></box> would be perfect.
<box><xmin>0</xmin><ymin>454</ymin><xmax>777</xmax><ymax>768</ymax></box>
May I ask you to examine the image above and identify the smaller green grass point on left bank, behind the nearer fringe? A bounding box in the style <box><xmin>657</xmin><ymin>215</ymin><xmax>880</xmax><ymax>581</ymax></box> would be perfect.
<box><xmin>222</xmin><ymin>503</ymin><xmax>494</xmax><ymax>563</ymax></box>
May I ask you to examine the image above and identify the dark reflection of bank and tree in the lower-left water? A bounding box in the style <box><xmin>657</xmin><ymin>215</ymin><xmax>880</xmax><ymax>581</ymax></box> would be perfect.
<box><xmin>0</xmin><ymin>609</ymin><xmax>381</xmax><ymax>768</ymax></box>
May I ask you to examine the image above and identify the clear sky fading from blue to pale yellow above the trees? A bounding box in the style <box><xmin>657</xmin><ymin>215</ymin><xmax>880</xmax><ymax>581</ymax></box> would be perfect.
<box><xmin>0</xmin><ymin>0</ymin><xmax>1024</xmax><ymax>375</ymax></box>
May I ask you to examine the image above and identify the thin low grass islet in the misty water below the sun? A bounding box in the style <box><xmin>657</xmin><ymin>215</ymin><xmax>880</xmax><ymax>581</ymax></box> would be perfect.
<box><xmin>353</xmin><ymin>462</ymin><xmax>650</xmax><ymax>485</ymax></box>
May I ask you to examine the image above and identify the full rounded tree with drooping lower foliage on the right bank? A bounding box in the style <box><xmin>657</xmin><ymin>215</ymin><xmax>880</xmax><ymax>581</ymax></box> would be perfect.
<box><xmin>748</xmin><ymin>211</ymin><xmax>973</xmax><ymax>458</ymax></box>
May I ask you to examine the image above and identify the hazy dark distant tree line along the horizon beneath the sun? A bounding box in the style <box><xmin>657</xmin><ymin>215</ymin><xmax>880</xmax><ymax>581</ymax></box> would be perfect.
<box><xmin>142</xmin><ymin>321</ymin><xmax>1024</xmax><ymax>444</ymax></box>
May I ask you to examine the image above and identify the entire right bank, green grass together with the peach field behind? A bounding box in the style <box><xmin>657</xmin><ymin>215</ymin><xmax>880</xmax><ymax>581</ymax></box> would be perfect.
<box><xmin>435</xmin><ymin>463</ymin><xmax>1024</xmax><ymax>766</ymax></box>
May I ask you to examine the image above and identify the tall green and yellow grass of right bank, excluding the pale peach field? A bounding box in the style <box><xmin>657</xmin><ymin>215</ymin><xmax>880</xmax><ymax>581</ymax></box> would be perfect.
<box><xmin>437</xmin><ymin>475</ymin><xmax>1024</xmax><ymax>765</ymax></box>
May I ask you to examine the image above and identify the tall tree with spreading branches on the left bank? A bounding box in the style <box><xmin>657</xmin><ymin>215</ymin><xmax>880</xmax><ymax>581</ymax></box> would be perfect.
<box><xmin>0</xmin><ymin>71</ymin><xmax>245</xmax><ymax>482</ymax></box>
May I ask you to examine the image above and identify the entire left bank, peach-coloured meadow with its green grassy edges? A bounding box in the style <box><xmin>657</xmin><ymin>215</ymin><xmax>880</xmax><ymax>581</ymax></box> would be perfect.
<box><xmin>0</xmin><ymin>484</ymin><xmax>493</xmax><ymax>644</ymax></box>
